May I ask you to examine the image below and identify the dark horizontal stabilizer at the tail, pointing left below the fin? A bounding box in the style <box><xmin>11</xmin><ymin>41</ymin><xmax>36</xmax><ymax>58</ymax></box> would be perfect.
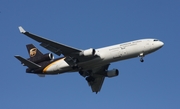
<box><xmin>14</xmin><ymin>55</ymin><xmax>41</xmax><ymax>69</ymax></box>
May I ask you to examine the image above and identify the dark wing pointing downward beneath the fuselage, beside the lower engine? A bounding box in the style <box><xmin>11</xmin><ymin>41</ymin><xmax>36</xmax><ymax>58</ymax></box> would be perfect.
<box><xmin>88</xmin><ymin>64</ymin><xmax>109</xmax><ymax>93</ymax></box>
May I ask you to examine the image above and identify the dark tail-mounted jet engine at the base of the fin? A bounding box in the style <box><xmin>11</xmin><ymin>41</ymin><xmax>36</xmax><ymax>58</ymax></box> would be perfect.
<box><xmin>28</xmin><ymin>53</ymin><xmax>54</xmax><ymax>63</ymax></box>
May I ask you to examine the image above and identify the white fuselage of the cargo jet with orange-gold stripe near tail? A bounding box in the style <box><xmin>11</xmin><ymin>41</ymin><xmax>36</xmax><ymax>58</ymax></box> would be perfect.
<box><xmin>43</xmin><ymin>39</ymin><xmax>164</xmax><ymax>74</ymax></box>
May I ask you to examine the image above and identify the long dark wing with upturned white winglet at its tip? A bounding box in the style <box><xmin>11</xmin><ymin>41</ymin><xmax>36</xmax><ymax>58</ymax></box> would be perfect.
<box><xmin>19</xmin><ymin>26</ymin><xmax>82</xmax><ymax>56</ymax></box>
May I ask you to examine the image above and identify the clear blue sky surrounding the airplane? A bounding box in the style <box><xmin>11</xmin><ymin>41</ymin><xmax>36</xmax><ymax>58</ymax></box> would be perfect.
<box><xmin>0</xmin><ymin>0</ymin><xmax>180</xmax><ymax>109</ymax></box>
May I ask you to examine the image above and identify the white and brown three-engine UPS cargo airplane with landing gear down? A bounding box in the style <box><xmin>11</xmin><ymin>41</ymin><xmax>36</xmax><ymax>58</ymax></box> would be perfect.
<box><xmin>15</xmin><ymin>26</ymin><xmax>164</xmax><ymax>94</ymax></box>
